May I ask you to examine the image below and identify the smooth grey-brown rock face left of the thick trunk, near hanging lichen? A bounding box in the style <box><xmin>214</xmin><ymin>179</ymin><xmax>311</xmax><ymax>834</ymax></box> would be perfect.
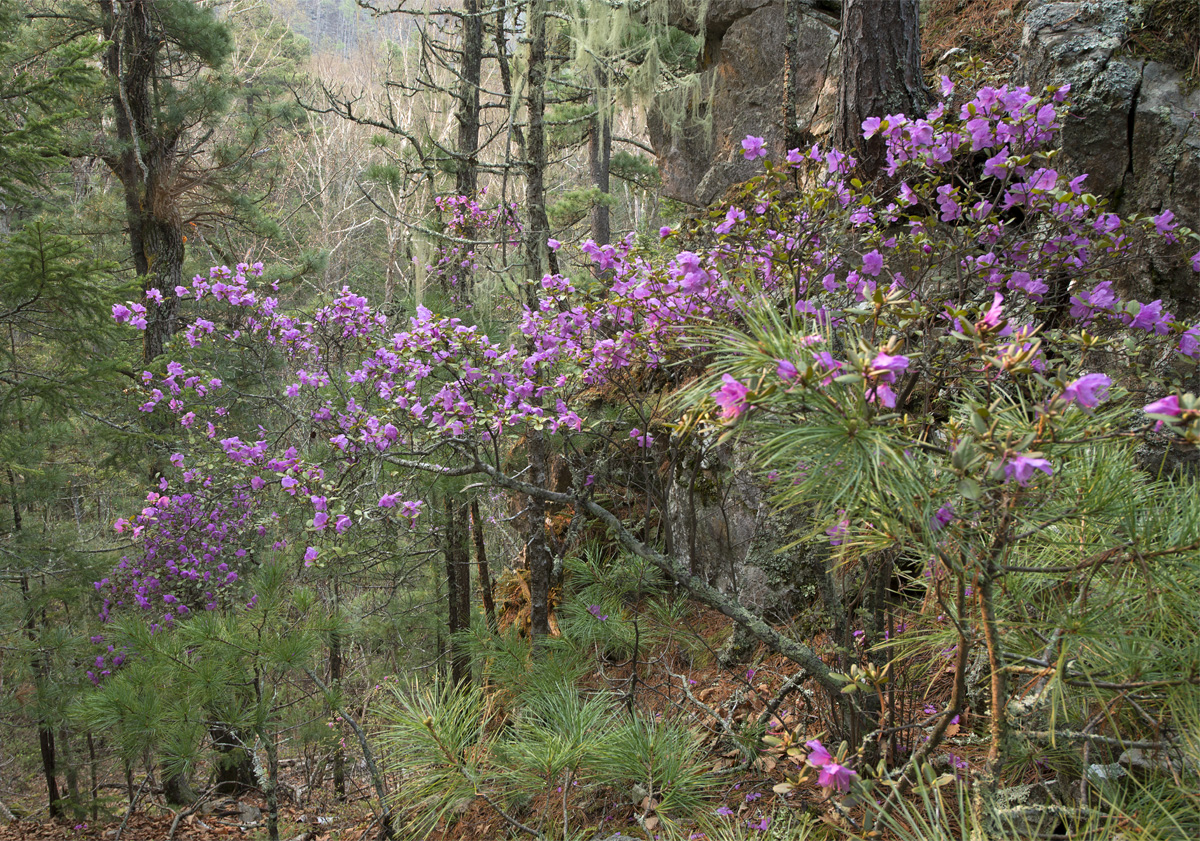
<box><xmin>649</xmin><ymin>0</ymin><xmax>838</xmax><ymax>206</ymax></box>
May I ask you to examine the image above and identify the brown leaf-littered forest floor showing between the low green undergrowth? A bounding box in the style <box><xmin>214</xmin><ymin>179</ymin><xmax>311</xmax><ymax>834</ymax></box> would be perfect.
<box><xmin>0</xmin><ymin>611</ymin><xmax>1003</xmax><ymax>841</ymax></box>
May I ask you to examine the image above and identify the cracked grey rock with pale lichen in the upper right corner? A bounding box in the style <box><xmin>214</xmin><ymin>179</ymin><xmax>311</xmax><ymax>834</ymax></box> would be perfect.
<box><xmin>1015</xmin><ymin>0</ymin><xmax>1200</xmax><ymax>317</ymax></box>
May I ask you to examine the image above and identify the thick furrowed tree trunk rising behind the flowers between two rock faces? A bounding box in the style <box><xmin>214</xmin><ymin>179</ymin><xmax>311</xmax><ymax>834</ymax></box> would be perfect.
<box><xmin>833</xmin><ymin>0</ymin><xmax>928</xmax><ymax>178</ymax></box>
